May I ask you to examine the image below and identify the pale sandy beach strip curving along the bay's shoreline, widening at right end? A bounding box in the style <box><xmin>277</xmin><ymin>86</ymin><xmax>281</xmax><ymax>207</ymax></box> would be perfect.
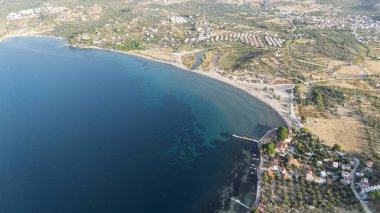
<box><xmin>0</xmin><ymin>34</ymin><xmax>292</xmax><ymax>126</ymax></box>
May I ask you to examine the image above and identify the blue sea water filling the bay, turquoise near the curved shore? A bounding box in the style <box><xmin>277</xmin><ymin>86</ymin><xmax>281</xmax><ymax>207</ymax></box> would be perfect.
<box><xmin>0</xmin><ymin>37</ymin><xmax>281</xmax><ymax>213</ymax></box>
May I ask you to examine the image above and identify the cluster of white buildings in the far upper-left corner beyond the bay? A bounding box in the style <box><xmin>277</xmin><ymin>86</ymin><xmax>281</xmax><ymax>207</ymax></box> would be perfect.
<box><xmin>6</xmin><ymin>6</ymin><xmax>67</xmax><ymax>21</ymax></box>
